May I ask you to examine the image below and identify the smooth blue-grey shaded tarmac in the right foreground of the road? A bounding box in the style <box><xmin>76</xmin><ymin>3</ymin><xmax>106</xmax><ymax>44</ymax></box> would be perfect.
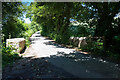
<box><xmin>46</xmin><ymin>52</ymin><xmax>120</xmax><ymax>78</ymax></box>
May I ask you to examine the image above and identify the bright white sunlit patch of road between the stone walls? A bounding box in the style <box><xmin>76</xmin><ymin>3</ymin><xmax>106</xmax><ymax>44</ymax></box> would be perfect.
<box><xmin>24</xmin><ymin>37</ymin><xmax>75</xmax><ymax>57</ymax></box>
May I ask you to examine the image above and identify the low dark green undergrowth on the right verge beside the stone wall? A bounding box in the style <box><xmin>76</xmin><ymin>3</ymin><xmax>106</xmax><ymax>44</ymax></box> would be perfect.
<box><xmin>81</xmin><ymin>41</ymin><xmax>120</xmax><ymax>60</ymax></box>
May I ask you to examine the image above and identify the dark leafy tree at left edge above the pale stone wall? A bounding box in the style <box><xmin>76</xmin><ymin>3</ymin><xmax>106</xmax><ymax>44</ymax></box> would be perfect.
<box><xmin>2</xmin><ymin>2</ymin><xmax>22</xmax><ymax>41</ymax></box>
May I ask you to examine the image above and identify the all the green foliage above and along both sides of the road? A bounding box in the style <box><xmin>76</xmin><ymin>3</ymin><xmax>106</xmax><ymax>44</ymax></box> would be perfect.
<box><xmin>2</xmin><ymin>2</ymin><xmax>120</xmax><ymax>64</ymax></box>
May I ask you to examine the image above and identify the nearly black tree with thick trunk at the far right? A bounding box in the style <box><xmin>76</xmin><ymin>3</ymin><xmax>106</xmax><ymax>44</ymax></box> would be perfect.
<box><xmin>93</xmin><ymin>2</ymin><xmax>120</xmax><ymax>50</ymax></box>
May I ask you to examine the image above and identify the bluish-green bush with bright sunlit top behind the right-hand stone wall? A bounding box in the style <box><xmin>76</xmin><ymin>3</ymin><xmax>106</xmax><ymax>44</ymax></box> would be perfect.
<box><xmin>69</xmin><ymin>22</ymin><xmax>95</xmax><ymax>37</ymax></box>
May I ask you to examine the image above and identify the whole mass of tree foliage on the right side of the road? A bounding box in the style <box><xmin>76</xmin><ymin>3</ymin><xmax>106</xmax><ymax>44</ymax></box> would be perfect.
<box><xmin>27</xmin><ymin>2</ymin><xmax>120</xmax><ymax>58</ymax></box>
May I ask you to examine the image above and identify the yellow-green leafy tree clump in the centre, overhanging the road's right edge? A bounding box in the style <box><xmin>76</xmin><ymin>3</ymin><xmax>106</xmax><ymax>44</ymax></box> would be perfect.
<box><xmin>27</xmin><ymin>3</ymin><xmax>72</xmax><ymax>43</ymax></box>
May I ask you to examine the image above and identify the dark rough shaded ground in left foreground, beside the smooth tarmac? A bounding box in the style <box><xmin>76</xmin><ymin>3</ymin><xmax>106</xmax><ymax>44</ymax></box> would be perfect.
<box><xmin>2</xmin><ymin>57</ymin><xmax>75</xmax><ymax>80</ymax></box>
